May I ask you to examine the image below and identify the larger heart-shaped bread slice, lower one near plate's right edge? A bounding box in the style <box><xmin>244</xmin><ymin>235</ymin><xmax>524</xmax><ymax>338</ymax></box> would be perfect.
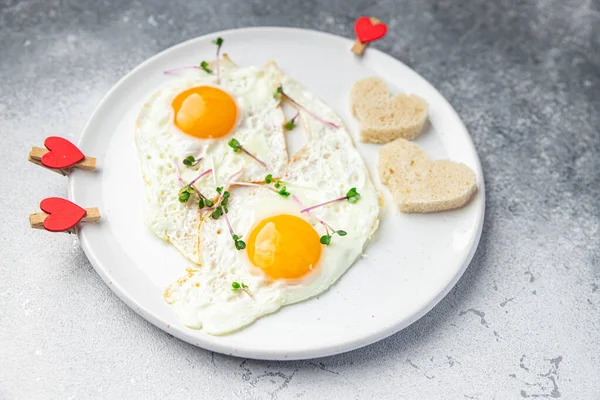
<box><xmin>379</xmin><ymin>139</ymin><xmax>477</xmax><ymax>213</ymax></box>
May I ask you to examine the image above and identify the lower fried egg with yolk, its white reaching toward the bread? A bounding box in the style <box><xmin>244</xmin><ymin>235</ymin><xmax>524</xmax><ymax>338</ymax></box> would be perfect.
<box><xmin>165</xmin><ymin>63</ymin><xmax>379</xmax><ymax>335</ymax></box>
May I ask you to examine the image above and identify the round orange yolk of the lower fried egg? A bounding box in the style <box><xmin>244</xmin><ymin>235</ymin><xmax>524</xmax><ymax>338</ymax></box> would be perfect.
<box><xmin>248</xmin><ymin>215</ymin><xmax>321</xmax><ymax>279</ymax></box>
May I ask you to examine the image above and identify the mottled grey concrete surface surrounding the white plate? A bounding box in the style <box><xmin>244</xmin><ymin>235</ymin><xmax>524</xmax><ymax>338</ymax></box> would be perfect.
<box><xmin>0</xmin><ymin>0</ymin><xmax>600</xmax><ymax>400</ymax></box>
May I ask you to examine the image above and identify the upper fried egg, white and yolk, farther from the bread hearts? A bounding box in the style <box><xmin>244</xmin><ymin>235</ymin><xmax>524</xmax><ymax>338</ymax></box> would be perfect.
<box><xmin>135</xmin><ymin>57</ymin><xmax>288</xmax><ymax>263</ymax></box>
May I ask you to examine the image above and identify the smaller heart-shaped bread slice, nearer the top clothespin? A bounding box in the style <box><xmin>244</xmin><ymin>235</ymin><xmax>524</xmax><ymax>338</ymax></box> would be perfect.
<box><xmin>350</xmin><ymin>77</ymin><xmax>428</xmax><ymax>143</ymax></box>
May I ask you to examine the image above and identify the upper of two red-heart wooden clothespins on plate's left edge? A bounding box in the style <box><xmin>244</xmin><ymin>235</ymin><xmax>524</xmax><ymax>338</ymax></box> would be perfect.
<box><xmin>29</xmin><ymin>136</ymin><xmax>96</xmax><ymax>175</ymax></box>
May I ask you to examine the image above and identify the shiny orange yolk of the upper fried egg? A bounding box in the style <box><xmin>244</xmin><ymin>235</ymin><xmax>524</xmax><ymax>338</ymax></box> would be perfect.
<box><xmin>171</xmin><ymin>86</ymin><xmax>238</xmax><ymax>139</ymax></box>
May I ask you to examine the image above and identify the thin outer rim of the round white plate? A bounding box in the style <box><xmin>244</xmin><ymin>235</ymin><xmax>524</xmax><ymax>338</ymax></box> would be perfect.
<box><xmin>68</xmin><ymin>26</ymin><xmax>486</xmax><ymax>361</ymax></box>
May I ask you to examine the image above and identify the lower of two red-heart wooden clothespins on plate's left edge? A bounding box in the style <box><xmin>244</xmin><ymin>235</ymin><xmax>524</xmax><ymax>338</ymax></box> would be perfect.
<box><xmin>29</xmin><ymin>197</ymin><xmax>100</xmax><ymax>233</ymax></box>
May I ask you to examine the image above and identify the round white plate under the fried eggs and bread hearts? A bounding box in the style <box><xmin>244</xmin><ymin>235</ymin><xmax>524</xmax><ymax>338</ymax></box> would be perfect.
<box><xmin>69</xmin><ymin>28</ymin><xmax>485</xmax><ymax>359</ymax></box>
